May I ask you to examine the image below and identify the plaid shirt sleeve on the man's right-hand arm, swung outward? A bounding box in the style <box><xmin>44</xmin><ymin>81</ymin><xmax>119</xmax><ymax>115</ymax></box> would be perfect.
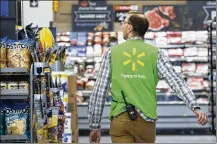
<box><xmin>157</xmin><ymin>50</ymin><xmax>200</xmax><ymax>111</ymax></box>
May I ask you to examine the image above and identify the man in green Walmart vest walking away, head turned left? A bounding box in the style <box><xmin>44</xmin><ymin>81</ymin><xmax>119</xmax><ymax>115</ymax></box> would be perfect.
<box><xmin>88</xmin><ymin>14</ymin><xmax>208</xmax><ymax>143</ymax></box>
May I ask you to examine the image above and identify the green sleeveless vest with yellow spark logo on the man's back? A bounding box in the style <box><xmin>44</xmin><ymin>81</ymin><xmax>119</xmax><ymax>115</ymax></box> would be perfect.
<box><xmin>110</xmin><ymin>40</ymin><xmax>158</xmax><ymax>119</ymax></box>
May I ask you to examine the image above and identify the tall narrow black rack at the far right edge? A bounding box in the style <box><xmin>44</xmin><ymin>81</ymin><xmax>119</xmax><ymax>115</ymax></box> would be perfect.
<box><xmin>208</xmin><ymin>22</ymin><xmax>216</xmax><ymax>134</ymax></box>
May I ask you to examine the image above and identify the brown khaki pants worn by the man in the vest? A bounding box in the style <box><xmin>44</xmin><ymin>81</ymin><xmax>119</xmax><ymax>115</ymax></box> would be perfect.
<box><xmin>110</xmin><ymin>112</ymin><xmax>156</xmax><ymax>143</ymax></box>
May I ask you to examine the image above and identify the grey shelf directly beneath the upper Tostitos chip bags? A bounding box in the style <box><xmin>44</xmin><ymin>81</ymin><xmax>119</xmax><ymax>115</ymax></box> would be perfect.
<box><xmin>0</xmin><ymin>68</ymin><xmax>29</xmax><ymax>75</ymax></box>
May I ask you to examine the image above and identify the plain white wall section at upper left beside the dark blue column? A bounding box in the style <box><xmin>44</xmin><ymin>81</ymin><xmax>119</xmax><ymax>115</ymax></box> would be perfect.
<box><xmin>23</xmin><ymin>1</ymin><xmax>53</xmax><ymax>27</ymax></box>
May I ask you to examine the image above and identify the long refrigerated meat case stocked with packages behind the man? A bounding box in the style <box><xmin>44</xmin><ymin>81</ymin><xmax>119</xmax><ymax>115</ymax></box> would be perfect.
<box><xmin>56</xmin><ymin>31</ymin><xmax>210</xmax><ymax>130</ymax></box>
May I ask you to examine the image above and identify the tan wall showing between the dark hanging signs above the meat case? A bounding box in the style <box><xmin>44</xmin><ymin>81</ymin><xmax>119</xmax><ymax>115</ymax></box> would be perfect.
<box><xmin>55</xmin><ymin>0</ymin><xmax>186</xmax><ymax>32</ymax></box>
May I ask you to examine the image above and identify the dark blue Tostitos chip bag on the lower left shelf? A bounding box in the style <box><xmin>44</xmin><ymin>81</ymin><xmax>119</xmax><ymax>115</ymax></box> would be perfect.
<box><xmin>5</xmin><ymin>102</ymin><xmax>29</xmax><ymax>139</ymax></box>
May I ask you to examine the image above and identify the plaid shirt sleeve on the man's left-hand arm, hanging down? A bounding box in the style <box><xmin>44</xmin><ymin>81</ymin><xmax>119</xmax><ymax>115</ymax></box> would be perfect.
<box><xmin>88</xmin><ymin>49</ymin><xmax>111</xmax><ymax>130</ymax></box>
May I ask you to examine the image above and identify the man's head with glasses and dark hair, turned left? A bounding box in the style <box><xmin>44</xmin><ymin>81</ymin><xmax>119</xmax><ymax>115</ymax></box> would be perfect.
<box><xmin>122</xmin><ymin>12</ymin><xmax>149</xmax><ymax>39</ymax></box>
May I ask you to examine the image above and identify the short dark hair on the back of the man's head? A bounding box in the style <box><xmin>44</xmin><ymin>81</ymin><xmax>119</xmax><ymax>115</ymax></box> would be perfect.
<box><xmin>128</xmin><ymin>14</ymin><xmax>149</xmax><ymax>37</ymax></box>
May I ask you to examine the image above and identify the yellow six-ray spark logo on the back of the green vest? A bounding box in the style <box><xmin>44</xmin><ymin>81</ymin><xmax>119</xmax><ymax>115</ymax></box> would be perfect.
<box><xmin>123</xmin><ymin>48</ymin><xmax>145</xmax><ymax>71</ymax></box>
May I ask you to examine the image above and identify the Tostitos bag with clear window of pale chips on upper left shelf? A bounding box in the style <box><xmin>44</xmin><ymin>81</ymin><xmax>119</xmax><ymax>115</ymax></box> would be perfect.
<box><xmin>7</xmin><ymin>39</ymin><xmax>34</xmax><ymax>69</ymax></box>
